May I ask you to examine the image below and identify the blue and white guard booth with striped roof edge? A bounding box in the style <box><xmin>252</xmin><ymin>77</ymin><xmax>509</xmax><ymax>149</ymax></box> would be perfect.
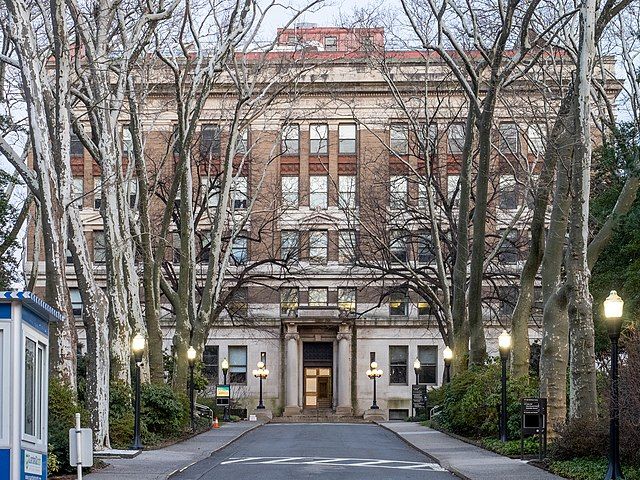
<box><xmin>0</xmin><ymin>291</ymin><xmax>62</xmax><ymax>480</ymax></box>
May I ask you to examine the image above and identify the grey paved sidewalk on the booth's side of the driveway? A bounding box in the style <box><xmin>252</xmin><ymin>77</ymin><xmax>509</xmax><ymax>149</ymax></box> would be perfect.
<box><xmin>85</xmin><ymin>421</ymin><xmax>262</xmax><ymax>480</ymax></box>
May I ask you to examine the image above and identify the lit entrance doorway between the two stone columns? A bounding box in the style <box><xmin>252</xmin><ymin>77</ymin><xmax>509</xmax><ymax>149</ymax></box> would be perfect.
<box><xmin>302</xmin><ymin>342</ymin><xmax>333</xmax><ymax>409</ymax></box>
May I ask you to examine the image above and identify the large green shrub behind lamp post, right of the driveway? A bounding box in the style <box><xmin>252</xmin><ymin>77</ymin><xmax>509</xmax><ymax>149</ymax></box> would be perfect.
<box><xmin>429</xmin><ymin>364</ymin><xmax>538</xmax><ymax>438</ymax></box>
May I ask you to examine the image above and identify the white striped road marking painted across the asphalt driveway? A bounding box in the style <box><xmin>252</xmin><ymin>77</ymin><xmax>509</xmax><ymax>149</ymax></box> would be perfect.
<box><xmin>220</xmin><ymin>457</ymin><xmax>446</xmax><ymax>472</ymax></box>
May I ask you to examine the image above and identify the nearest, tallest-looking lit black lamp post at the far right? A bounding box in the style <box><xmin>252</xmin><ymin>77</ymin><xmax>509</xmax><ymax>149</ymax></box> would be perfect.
<box><xmin>604</xmin><ymin>290</ymin><xmax>624</xmax><ymax>480</ymax></box>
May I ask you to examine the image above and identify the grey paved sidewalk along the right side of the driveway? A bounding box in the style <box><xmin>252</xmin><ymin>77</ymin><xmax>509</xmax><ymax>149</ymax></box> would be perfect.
<box><xmin>380</xmin><ymin>422</ymin><xmax>562</xmax><ymax>480</ymax></box>
